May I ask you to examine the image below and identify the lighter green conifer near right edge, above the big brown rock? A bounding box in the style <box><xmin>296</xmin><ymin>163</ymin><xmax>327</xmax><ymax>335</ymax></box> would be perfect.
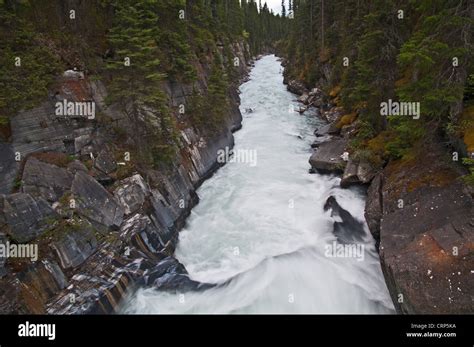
<box><xmin>397</xmin><ymin>9</ymin><xmax>469</xmax><ymax>119</ymax></box>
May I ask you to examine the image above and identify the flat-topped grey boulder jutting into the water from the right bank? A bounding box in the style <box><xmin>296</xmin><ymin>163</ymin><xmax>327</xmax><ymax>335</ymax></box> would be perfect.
<box><xmin>309</xmin><ymin>139</ymin><xmax>347</xmax><ymax>173</ymax></box>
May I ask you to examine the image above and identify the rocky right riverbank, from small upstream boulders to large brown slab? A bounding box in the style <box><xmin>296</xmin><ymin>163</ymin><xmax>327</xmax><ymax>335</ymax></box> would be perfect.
<box><xmin>285</xmin><ymin>72</ymin><xmax>474</xmax><ymax>314</ymax></box>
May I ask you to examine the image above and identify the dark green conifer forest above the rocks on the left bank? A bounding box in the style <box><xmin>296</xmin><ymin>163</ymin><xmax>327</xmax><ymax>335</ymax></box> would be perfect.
<box><xmin>0</xmin><ymin>0</ymin><xmax>287</xmax><ymax>167</ymax></box>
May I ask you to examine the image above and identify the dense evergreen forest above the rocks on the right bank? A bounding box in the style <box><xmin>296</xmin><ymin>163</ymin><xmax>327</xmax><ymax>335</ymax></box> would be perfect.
<box><xmin>285</xmin><ymin>0</ymin><xmax>474</xmax><ymax>168</ymax></box>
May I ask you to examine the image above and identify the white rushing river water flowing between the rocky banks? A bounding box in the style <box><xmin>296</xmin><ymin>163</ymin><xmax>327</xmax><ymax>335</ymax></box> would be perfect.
<box><xmin>124</xmin><ymin>56</ymin><xmax>393</xmax><ymax>313</ymax></box>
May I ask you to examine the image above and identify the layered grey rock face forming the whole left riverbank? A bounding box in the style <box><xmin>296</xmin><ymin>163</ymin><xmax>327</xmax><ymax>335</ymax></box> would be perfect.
<box><xmin>0</xmin><ymin>42</ymin><xmax>250</xmax><ymax>314</ymax></box>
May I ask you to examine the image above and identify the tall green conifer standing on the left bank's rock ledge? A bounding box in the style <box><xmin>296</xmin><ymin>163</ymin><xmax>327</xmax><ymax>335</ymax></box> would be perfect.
<box><xmin>107</xmin><ymin>0</ymin><xmax>176</xmax><ymax>166</ymax></box>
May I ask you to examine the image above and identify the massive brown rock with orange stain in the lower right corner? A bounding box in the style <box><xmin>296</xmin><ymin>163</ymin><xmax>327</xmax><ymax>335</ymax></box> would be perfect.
<box><xmin>366</xmin><ymin>143</ymin><xmax>474</xmax><ymax>314</ymax></box>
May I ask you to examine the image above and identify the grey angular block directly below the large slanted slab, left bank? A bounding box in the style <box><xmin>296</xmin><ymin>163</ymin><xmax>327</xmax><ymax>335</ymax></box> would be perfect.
<box><xmin>51</xmin><ymin>220</ymin><xmax>97</xmax><ymax>269</ymax></box>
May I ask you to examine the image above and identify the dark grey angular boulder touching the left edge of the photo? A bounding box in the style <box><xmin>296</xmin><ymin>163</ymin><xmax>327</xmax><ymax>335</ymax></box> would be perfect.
<box><xmin>3</xmin><ymin>193</ymin><xmax>56</xmax><ymax>243</ymax></box>
